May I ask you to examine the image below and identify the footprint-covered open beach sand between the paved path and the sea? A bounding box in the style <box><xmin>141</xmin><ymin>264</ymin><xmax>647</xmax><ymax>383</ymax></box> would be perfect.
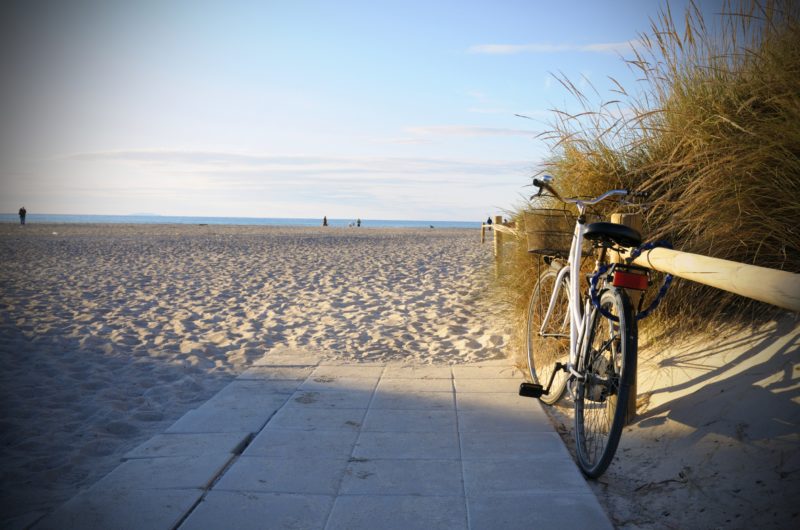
<box><xmin>0</xmin><ymin>224</ymin><xmax>509</xmax><ymax>527</ymax></box>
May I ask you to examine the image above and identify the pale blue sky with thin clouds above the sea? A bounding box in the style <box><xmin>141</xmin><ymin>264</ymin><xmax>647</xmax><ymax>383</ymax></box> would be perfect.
<box><xmin>0</xmin><ymin>0</ymin><xmax>724</xmax><ymax>221</ymax></box>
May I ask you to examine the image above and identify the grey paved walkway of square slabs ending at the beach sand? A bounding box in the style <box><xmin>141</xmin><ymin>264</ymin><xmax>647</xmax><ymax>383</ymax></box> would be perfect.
<box><xmin>35</xmin><ymin>349</ymin><xmax>611</xmax><ymax>530</ymax></box>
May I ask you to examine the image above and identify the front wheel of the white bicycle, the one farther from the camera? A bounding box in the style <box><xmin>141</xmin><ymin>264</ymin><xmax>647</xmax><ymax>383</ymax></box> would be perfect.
<box><xmin>525</xmin><ymin>268</ymin><xmax>570</xmax><ymax>405</ymax></box>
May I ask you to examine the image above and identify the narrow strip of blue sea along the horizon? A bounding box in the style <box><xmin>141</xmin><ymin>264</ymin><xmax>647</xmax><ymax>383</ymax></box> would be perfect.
<box><xmin>0</xmin><ymin>213</ymin><xmax>481</xmax><ymax>228</ymax></box>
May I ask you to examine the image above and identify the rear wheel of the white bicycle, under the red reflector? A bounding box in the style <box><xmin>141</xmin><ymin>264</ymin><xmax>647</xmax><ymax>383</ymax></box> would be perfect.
<box><xmin>575</xmin><ymin>289</ymin><xmax>637</xmax><ymax>478</ymax></box>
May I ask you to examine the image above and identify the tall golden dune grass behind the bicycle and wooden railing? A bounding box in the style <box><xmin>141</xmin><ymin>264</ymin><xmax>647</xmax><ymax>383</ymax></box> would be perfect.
<box><xmin>497</xmin><ymin>0</ymin><xmax>800</xmax><ymax>358</ymax></box>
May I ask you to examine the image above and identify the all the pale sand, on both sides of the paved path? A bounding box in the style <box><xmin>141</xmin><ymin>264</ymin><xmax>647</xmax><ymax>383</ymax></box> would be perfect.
<box><xmin>0</xmin><ymin>224</ymin><xmax>800</xmax><ymax>529</ymax></box>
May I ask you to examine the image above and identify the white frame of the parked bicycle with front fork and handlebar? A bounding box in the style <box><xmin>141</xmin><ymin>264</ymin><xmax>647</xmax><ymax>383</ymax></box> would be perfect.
<box><xmin>539</xmin><ymin>190</ymin><xmax>628</xmax><ymax>379</ymax></box>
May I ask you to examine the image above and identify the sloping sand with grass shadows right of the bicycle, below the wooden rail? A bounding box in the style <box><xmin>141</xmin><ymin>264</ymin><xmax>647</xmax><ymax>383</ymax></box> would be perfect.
<box><xmin>550</xmin><ymin>315</ymin><xmax>800</xmax><ymax>530</ymax></box>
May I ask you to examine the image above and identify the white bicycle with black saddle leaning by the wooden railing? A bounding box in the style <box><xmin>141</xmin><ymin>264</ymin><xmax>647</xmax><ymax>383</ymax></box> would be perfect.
<box><xmin>519</xmin><ymin>177</ymin><xmax>671</xmax><ymax>478</ymax></box>
